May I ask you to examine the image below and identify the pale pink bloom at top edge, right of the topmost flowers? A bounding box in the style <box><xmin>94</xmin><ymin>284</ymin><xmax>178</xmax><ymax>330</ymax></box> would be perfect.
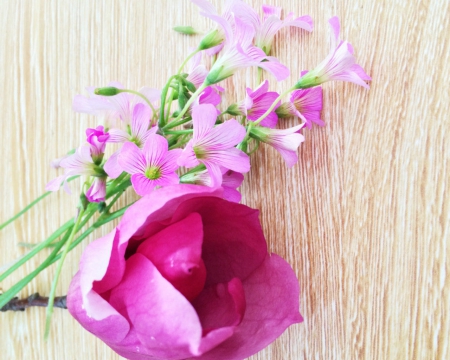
<box><xmin>233</xmin><ymin>1</ymin><xmax>313</xmax><ymax>55</ymax></box>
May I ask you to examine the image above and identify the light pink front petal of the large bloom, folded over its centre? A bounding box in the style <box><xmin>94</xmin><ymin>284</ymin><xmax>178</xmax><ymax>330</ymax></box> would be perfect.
<box><xmin>109</xmin><ymin>254</ymin><xmax>202</xmax><ymax>359</ymax></box>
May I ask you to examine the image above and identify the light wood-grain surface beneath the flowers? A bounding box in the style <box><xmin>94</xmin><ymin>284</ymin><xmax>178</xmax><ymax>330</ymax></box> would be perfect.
<box><xmin>0</xmin><ymin>0</ymin><xmax>450</xmax><ymax>360</ymax></box>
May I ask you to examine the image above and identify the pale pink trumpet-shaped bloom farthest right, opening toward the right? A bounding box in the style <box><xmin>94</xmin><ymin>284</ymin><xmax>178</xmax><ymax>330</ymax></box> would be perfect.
<box><xmin>295</xmin><ymin>16</ymin><xmax>371</xmax><ymax>89</ymax></box>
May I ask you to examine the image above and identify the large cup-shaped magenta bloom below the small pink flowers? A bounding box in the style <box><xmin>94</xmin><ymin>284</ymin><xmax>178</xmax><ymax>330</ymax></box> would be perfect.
<box><xmin>67</xmin><ymin>185</ymin><xmax>302</xmax><ymax>360</ymax></box>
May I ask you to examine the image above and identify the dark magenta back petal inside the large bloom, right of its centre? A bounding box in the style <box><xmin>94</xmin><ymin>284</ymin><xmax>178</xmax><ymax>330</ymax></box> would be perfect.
<box><xmin>172</xmin><ymin>197</ymin><xmax>267</xmax><ymax>286</ymax></box>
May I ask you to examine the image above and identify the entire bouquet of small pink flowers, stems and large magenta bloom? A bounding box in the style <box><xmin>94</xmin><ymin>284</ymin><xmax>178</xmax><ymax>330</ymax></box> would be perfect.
<box><xmin>0</xmin><ymin>0</ymin><xmax>370</xmax><ymax>360</ymax></box>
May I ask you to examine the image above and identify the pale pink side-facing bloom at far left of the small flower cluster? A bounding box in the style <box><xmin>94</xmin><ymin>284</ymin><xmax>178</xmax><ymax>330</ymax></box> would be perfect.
<box><xmin>45</xmin><ymin>145</ymin><xmax>106</xmax><ymax>202</ymax></box>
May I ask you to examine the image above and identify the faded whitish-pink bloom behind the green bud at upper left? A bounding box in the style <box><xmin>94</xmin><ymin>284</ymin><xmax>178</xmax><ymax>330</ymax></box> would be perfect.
<box><xmin>72</xmin><ymin>82</ymin><xmax>161</xmax><ymax>124</ymax></box>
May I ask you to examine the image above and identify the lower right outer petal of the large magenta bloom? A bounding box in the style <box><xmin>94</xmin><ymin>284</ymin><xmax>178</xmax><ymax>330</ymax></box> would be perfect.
<box><xmin>192</xmin><ymin>254</ymin><xmax>303</xmax><ymax>360</ymax></box>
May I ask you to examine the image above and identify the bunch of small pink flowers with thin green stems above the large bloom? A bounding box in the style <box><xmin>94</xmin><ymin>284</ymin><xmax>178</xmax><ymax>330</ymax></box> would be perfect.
<box><xmin>0</xmin><ymin>0</ymin><xmax>370</xmax><ymax>358</ymax></box>
